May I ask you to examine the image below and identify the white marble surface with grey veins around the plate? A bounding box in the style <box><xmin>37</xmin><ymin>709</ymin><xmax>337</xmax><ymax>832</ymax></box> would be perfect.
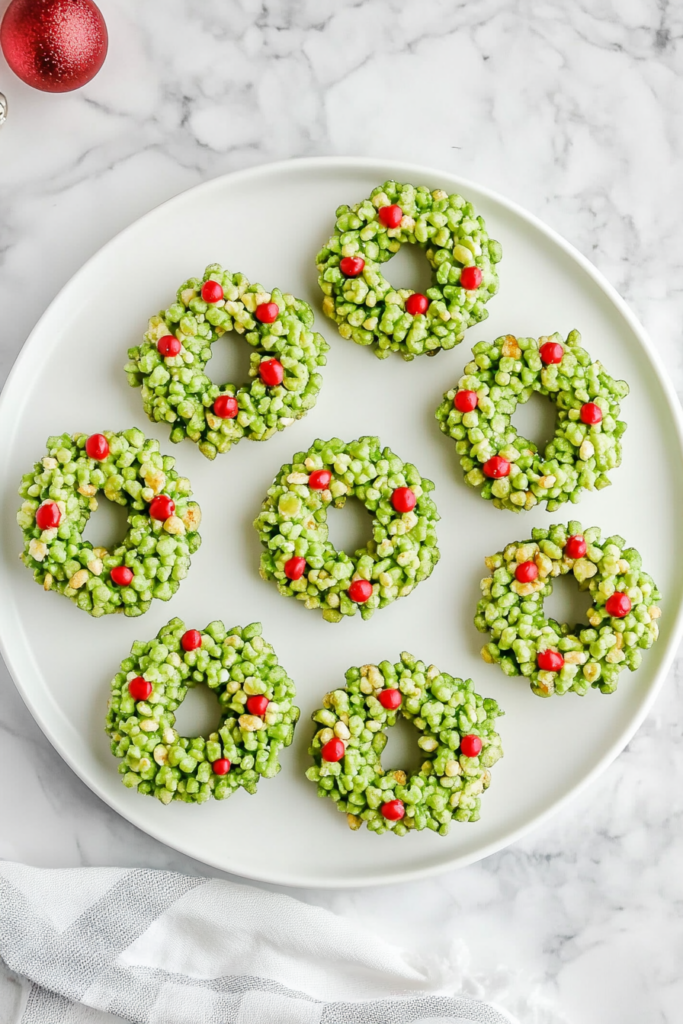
<box><xmin>0</xmin><ymin>0</ymin><xmax>683</xmax><ymax>1024</ymax></box>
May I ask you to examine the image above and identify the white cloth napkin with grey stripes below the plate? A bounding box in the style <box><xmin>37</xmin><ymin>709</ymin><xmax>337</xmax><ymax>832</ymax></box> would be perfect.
<box><xmin>0</xmin><ymin>861</ymin><xmax>561</xmax><ymax>1024</ymax></box>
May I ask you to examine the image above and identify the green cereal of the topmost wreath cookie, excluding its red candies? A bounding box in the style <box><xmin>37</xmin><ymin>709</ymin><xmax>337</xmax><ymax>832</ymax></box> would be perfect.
<box><xmin>316</xmin><ymin>181</ymin><xmax>503</xmax><ymax>360</ymax></box>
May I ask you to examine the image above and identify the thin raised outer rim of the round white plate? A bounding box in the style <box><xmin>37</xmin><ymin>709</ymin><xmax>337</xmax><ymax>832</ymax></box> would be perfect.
<box><xmin>0</xmin><ymin>156</ymin><xmax>683</xmax><ymax>890</ymax></box>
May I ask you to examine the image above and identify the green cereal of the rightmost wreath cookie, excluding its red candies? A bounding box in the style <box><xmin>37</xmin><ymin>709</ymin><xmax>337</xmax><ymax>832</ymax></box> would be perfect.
<box><xmin>474</xmin><ymin>522</ymin><xmax>660</xmax><ymax>696</ymax></box>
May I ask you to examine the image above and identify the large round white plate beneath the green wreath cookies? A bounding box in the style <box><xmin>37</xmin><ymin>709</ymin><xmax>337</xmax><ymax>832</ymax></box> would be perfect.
<box><xmin>0</xmin><ymin>158</ymin><xmax>683</xmax><ymax>887</ymax></box>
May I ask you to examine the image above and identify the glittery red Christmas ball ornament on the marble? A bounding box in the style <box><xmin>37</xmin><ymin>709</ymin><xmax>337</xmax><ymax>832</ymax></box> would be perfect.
<box><xmin>0</xmin><ymin>0</ymin><xmax>109</xmax><ymax>92</ymax></box>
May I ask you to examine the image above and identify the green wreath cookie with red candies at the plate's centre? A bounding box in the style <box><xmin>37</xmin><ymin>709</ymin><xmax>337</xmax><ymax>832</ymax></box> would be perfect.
<box><xmin>254</xmin><ymin>437</ymin><xmax>439</xmax><ymax>623</ymax></box>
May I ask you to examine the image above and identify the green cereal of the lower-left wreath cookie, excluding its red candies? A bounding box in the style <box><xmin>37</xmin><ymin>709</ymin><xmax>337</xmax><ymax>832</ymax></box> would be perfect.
<box><xmin>106</xmin><ymin>618</ymin><xmax>299</xmax><ymax>804</ymax></box>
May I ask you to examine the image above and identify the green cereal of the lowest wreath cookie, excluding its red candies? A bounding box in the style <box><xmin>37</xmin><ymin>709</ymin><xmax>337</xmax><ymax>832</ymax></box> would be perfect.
<box><xmin>306</xmin><ymin>652</ymin><xmax>503</xmax><ymax>836</ymax></box>
